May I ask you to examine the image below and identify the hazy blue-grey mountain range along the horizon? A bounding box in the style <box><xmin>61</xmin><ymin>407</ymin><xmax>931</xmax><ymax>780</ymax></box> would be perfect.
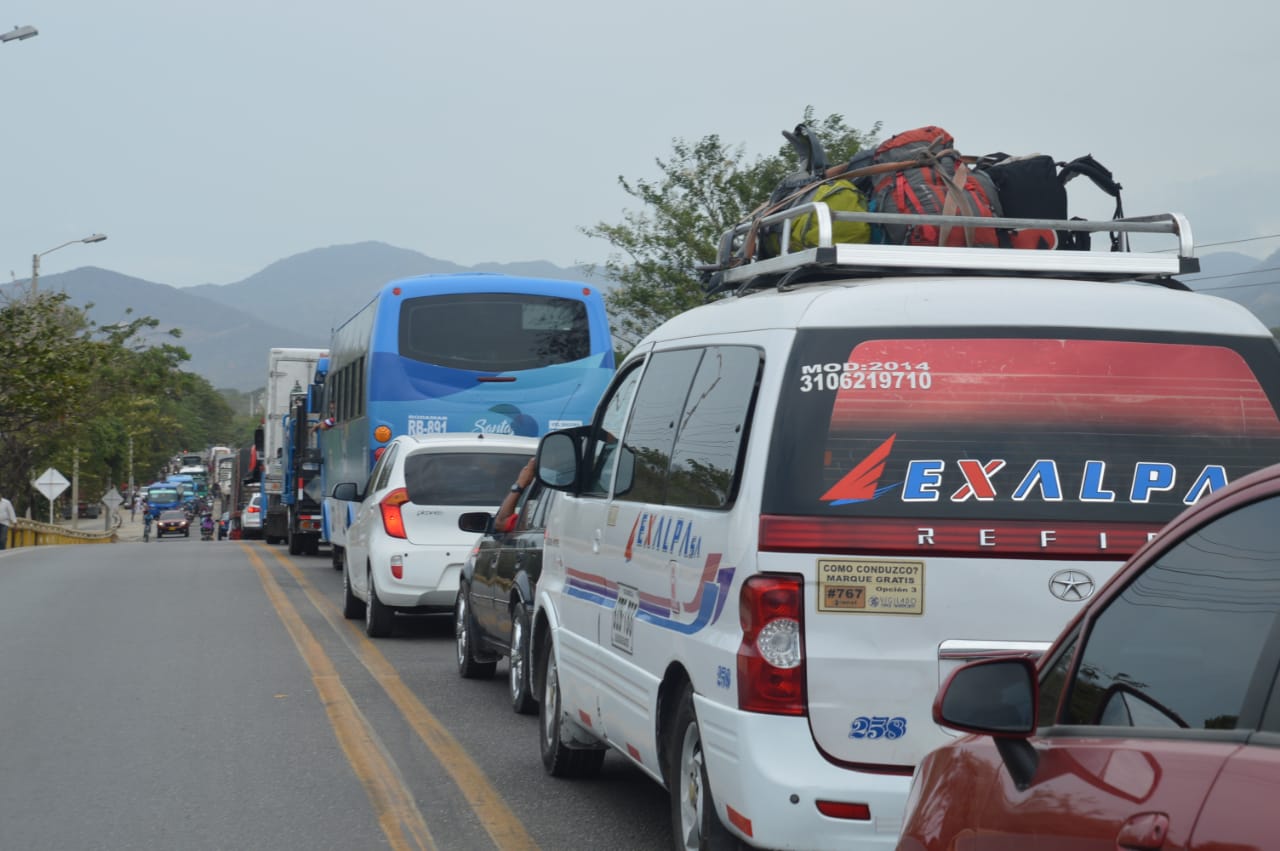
<box><xmin>0</xmin><ymin>242</ymin><xmax>1280</xmax><ymax>392</ymax></box>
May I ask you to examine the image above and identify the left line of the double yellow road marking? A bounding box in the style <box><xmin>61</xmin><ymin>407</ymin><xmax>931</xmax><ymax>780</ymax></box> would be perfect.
<box><xmin>241</xmin><ymin>544</ymin><xmax>436</xmax><ymax>851</ymax></box>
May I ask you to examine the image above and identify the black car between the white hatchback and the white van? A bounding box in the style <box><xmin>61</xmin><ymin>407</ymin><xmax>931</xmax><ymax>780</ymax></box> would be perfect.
<box><xmin>454</xmin><ymin>481</ymin><xmax>554</xmax><ymax>714</ymax></box>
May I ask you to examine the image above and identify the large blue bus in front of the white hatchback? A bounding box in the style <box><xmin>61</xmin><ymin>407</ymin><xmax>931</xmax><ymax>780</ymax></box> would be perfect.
<box><xmin>320</xmin><ymin>274</ymin><xmax>614</xmax><ymax>568</ymax></box>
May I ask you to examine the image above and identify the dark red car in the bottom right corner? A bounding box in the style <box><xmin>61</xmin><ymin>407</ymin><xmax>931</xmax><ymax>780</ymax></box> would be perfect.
<box><xmin>897</xmin><ymin>465</ymin><xmax>1280</xmax><ymax>851</ymax></box>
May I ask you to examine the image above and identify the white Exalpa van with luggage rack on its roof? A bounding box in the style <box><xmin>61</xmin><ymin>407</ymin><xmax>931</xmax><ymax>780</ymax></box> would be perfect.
<box><xmin>524</xmin><ymin>205</ymin><xmax>1280</xmax><ymax>850</ymax></box>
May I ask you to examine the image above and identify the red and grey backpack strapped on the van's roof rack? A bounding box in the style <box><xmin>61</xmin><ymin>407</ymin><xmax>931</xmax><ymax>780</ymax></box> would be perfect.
<box><xmin>869</xmin><ymin>125</ymin><xmax>1001</xmax><ymax>248</ymax></box>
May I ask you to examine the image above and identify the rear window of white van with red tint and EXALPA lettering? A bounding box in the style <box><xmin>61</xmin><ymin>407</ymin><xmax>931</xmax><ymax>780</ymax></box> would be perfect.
<box><xmin>763</xmin><ymin>329</ymin><xmax>1280</xmax><ymax>555</ymax></box>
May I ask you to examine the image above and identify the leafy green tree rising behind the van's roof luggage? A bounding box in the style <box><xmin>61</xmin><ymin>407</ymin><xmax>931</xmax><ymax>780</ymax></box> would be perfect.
<box><xmin>582</xmin><ymin>106</ymin><xmax>881</xmax><ymax>348</ymax></box>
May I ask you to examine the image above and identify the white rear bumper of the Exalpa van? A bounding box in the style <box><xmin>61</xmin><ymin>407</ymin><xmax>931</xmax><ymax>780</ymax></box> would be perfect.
<box><xmin>694</xmin><ymin>695</ymin><xmax>911</xmax><ymax>851</ymax></box>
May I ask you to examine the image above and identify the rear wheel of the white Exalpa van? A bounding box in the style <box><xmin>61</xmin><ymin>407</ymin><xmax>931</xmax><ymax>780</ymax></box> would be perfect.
<box><xmin>667</xmin><ymin>683</ymin><xmax>744</xmax><ymax>851</ymax></box>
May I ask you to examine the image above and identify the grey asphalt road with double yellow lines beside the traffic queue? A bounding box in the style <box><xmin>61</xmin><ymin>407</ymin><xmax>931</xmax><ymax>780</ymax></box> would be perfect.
<box><xmin>0</xmin><ymin>532</ymin><xmax>671</xmax><ymax>851</ymax></box>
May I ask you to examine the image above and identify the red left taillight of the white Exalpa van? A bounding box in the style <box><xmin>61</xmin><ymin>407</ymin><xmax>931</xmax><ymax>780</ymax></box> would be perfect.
<box><xmin>737</xmin><ymin>575</ymin><xmax>808</xmax><ymax>715</ymax></box>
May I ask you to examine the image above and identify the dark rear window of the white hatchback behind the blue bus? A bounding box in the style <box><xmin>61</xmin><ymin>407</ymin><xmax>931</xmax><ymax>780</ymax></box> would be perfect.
<box><xmin>404</xmin><ymin>452</ymin><xmax>532</xmax><ymax>507</ymax></box>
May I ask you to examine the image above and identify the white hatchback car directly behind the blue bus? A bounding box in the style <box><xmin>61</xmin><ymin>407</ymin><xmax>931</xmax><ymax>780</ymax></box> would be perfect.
<box><xmin>334</xmin><ymin>434</ymin><xmax>538</xmax><ymax>637</ymax></box>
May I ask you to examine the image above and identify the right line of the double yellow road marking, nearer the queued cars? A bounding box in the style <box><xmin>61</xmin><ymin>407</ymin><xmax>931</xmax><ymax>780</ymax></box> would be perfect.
<box><xmin>264</xmin><ymin>550</ymin><xmax>538</xmax><ymax>851</ymax></box>
